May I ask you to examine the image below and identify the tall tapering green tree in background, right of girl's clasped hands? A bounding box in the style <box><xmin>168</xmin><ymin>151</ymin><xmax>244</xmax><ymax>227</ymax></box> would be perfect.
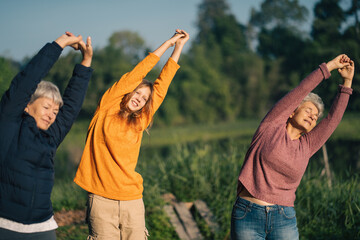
<box><xmin>177</xmin><ymin>0</ymin><xmax>268</xmax><ymax>121</ymax></box>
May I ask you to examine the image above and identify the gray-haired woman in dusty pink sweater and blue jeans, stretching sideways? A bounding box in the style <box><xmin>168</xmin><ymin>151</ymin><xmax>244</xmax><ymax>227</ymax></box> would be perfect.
<box><xmin>231</xmin><ymin>54</ymin><xmax>354</xmax><ymax>240</ymax></box>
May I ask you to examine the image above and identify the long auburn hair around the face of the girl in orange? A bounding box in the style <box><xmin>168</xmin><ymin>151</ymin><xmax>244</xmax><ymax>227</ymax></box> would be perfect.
<box><xmin>119</xmin><ymin>79</ymin><xmax>154</xmax><ymax>133</ymax></box>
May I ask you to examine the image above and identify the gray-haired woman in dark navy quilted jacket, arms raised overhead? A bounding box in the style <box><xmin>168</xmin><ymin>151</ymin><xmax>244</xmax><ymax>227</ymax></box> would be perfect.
<box><xmin>0</xmin><ymin>32</ymin><xmax>93</xmax><ymax>240</ymax></box>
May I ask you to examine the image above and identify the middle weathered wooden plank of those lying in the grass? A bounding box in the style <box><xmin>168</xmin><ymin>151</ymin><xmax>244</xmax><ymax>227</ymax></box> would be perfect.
<box><xmin>174</xmin><ymin>202</ymin><xmax>204</xmax><ymax>240</ymax></box>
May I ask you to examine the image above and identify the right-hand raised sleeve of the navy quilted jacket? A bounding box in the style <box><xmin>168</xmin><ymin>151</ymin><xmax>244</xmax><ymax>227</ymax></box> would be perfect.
<box><xmin>48</xmin><ymin>64</ymin><xmax>93</xmax><ymax>146</ymax></box>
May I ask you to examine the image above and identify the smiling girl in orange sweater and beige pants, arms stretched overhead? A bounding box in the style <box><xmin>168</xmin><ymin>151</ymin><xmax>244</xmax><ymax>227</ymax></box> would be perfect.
<box><xmin>74</xmin><ymin>29</ymin><xmax>189</xmax><ymax>240</ymax></box>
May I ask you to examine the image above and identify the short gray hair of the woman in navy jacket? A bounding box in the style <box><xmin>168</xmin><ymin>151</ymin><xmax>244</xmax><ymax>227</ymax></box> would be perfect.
<box><xmin>29</xmin><ymin>81</ymin><xmax>64</xmax><ymax>107</ymax></box>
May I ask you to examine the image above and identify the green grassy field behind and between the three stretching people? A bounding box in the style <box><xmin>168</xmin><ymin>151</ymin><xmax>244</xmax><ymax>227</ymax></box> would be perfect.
<box><xmin>52</xmin><ymin>116</ymin><xmax>360</xmax><ymax>240</ymax></box>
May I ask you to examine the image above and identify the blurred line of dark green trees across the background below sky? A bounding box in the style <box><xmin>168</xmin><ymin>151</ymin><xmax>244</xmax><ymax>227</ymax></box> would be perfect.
<box><xmin>0</xmin><ymin>0</ymin><xmax>360</xmax><ymax>125</ymax></box>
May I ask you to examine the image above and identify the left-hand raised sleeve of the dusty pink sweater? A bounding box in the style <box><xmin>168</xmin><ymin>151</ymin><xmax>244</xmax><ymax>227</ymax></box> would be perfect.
<box><xmin>262</xmin><ymin>63</ymin><xmax>330</xmax><ymax>123</ymax></box>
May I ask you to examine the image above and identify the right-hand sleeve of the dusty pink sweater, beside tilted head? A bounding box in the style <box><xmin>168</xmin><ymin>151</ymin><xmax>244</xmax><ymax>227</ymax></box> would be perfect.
<box><xmin>302</xmin><ymin>85</ymin><xmax>353</xmax><ymax>156</ymax></box>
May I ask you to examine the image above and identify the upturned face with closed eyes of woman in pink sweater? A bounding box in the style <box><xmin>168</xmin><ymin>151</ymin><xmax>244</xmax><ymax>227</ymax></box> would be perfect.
<box><xmin>289</xmin><ymin>102</ymin><xmax>319</xmax><ymax>133</ymax></box>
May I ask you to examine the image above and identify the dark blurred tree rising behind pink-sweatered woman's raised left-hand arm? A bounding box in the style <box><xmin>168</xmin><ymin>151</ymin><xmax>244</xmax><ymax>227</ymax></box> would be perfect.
<box><xmin>248</xmin><ymin>0</ymin><xmax>309</xmax><ymax>109</ymax></box>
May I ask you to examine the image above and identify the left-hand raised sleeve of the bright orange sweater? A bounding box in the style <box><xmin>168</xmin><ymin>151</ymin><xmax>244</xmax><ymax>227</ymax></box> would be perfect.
<box><xmin>98</xmin><ymin>53</ymin><xmax>160</xmax><ymax>110</ymax></box>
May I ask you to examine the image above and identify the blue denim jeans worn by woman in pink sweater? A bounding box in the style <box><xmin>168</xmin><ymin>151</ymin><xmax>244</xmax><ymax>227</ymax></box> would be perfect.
<box><xmin>231</xmin><ymin>197</ymin><xmax>299</xmax><ymax>240</ymax></box>
